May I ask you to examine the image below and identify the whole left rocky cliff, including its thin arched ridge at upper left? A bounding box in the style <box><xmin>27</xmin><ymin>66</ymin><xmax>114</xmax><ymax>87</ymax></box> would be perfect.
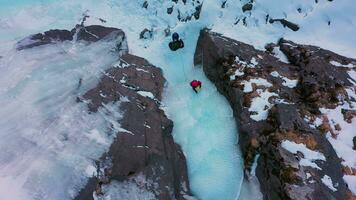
<box><xmin>17</xmin><ymin>25</ymin><xmax>194</xmax><ymax>200</ymax></box>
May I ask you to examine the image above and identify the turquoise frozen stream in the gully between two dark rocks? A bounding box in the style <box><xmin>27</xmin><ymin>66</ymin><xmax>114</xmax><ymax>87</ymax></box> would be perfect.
<box><xmin>135</xmin><ymin>23</ymin><xmax>243</xmax><ymax>200</ymax></box>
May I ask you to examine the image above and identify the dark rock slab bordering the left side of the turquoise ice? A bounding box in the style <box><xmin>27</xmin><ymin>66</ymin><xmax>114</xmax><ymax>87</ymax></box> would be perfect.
<box><xmin>77</xmin><ymin>54</ymin><xmax>195</xmax><ymax>199</ymax></box>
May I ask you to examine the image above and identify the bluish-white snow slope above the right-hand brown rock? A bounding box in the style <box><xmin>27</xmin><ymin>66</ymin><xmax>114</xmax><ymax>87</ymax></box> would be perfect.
<box><xmin>201</xmin><ymin>0</ymin><xmax>356</xmax><ymax>58</ymax></box>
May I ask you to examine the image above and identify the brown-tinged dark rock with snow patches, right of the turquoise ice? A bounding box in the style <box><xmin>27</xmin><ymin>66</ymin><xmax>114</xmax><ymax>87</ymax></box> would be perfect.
<box><xmin>194</xmin><ymin>30</ymin><xmax>356</xmax><ymax>200</ymax></box>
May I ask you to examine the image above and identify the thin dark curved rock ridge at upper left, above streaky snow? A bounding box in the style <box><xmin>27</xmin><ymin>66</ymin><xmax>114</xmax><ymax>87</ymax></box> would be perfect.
<box><xmin>16</xmin><ymin>25</ymin><xmax>125</xmax><ymax>50</ymax></box>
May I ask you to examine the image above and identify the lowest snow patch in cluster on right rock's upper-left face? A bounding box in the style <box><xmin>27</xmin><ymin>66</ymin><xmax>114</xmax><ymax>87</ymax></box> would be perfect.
<box><xmin>248</xmin><ymin>89</ymin><xmax>278</xmax><ymax>121</ymax></box>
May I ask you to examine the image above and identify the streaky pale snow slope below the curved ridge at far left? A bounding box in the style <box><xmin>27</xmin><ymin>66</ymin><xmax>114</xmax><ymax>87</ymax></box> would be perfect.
<box><xmin>0</xmin><ymin>39</ymin><xmax>121</xmax><ymax>199</ymax></box>
